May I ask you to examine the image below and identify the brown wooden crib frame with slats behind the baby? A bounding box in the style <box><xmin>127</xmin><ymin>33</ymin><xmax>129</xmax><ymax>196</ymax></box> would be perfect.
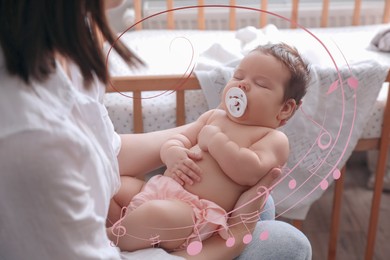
<box><xmin>107</xmin><ymin>0</ymin><xmax>390</xmax><ymax>259</ymax></box>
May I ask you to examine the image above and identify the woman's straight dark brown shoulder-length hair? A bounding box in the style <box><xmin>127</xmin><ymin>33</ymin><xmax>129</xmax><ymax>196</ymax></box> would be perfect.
<box><xmin>0</xmin><ymin>0</ymin><xmax>142</xmax><ymax>86</ymax></box>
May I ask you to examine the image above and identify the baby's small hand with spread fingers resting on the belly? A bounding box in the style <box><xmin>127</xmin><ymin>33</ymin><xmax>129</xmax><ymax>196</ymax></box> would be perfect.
<box><xmin>165</xmin><ymin>147</ymin><xmax>202</xmax><ymax>185</ymax></box>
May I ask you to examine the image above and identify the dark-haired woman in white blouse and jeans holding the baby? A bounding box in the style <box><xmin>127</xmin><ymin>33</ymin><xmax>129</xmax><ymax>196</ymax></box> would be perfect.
<box><xmin>0</xmin><ymin>0</ymin><xmax>311</xmax><ymax>259</ymax></box>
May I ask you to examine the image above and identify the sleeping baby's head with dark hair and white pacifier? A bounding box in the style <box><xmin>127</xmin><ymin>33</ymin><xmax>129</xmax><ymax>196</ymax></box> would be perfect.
<box><xmin>222</xmin><ymin>43</ymin><xmax>310</xmax><ymax>128</ymax></box>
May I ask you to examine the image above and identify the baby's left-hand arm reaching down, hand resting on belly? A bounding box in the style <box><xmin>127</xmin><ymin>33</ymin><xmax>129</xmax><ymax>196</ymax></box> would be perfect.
<box><xmin>160</xmin><ymin>111</ymin><xmax>212</xmax><ymax>185</ymax></box>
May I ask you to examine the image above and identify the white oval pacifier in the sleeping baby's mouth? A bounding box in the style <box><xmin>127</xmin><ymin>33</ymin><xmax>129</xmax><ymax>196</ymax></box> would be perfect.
<box><xmin>225</xmin><ymin>87</ymin><xmax>247</xmax><ymax>117</ymax></box>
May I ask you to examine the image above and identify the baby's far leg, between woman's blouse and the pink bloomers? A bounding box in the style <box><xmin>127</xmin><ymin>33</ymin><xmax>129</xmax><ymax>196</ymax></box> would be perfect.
<box><xmin>106</xmin><ymin>176</ymin><xmax>145</xmax><ymax>227</ymax></box>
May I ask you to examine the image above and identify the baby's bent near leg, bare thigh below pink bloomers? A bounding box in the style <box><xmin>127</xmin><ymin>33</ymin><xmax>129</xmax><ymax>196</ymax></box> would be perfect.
<box><xmin>107</xmin><ymin>200</ymin><xmax>193</xmax><ymax>251</ymax></box>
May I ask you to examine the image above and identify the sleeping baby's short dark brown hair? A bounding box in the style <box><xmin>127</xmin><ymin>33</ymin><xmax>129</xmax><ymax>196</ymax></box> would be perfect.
<box><xmin>253</xmin><ymin>43</ymin><xmax>310</xmax><ymax>104</ymax></box>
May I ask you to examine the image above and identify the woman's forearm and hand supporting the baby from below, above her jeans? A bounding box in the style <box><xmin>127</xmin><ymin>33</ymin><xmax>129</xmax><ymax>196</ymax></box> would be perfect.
<box><xmin>173</xmin><ymin>168</ymin><xmax>281</xmax><ymax>260</ymax></box>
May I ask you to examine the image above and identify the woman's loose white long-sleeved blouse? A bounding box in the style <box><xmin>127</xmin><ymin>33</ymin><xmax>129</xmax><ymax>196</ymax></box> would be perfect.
<box><xmin>0</xmin><ymin>49</ymin><xmax>120</xmax><ymax>259</ymax></box>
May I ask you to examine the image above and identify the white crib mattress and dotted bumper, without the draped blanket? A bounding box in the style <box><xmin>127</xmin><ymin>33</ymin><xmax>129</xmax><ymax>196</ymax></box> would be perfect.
<box><xmin>105</xmin><ymin>25</ymin><xmax>390</xmax><ymax>138</ymax></box>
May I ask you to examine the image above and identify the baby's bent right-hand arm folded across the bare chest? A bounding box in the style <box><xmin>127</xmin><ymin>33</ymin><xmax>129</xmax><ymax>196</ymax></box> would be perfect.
<box><xmin>207</xmin><ymin>130</ymin><xmax>289</xmax><ymax>186</ymax></box>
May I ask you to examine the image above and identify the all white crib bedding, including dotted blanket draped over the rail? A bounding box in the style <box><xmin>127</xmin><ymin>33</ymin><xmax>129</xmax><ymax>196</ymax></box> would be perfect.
<box><xmin>105</xmin><ymin>25</ymin><xmax>390</xmax><ymax>219</ymax></box>
